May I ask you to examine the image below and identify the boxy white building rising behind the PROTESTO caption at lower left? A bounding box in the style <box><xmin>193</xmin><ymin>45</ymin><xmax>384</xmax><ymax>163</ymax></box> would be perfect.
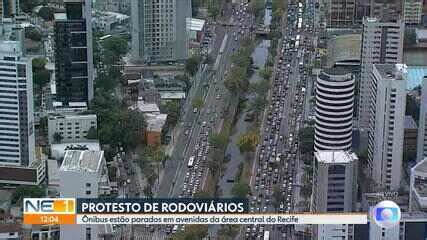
<box><xmin>59</xmin><ymin>150</ymin><xmax>109</xmax><ymax>240</ymax></box>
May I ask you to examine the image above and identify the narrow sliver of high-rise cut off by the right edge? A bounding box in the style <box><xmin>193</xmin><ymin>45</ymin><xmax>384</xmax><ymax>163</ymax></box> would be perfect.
<box><xmin>417</xmin><ymin>76</ymin><xmax>427</xmax><ymax>162</ymax></box>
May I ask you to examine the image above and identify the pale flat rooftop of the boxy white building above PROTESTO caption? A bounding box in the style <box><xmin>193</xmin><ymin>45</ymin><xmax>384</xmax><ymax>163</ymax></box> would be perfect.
<box><xmin>59</xmin><ymin>150</ymin><xmax>104</xmax><ymax>172</ymax></box>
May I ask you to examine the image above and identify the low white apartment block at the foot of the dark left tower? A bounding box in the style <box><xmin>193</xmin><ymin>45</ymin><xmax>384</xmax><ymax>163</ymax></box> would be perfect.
<box><xmin>48</xmin><ymin>114</ymin><xmax>97</xmax><ymax>144</ymax></box>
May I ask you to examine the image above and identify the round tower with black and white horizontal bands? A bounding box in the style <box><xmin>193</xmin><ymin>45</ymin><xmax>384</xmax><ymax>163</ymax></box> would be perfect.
<box><xmin>314</xmin><ymin>68</ymin><xmax>355</xmax><ymax>151</ymax></box>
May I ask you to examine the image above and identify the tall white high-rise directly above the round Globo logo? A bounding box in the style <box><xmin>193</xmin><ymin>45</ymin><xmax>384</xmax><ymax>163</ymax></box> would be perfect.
<box><xmin>368</xmin><ymin>64</ymin><xmax>406</xmax><ymax>190</ymax></box>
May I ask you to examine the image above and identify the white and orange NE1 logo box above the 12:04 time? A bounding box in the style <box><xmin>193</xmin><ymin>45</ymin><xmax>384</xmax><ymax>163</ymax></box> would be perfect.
<box><xmin>24</xmin><ymin>198</ymin><xmax>76</xmax><ymax>214</ymax></box>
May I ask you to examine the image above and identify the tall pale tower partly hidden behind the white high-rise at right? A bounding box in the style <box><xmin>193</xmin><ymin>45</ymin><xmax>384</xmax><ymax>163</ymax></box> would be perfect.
<box><xmin>358</xmin><ymin>18</ymin><xmax>405</xmax><ymax>131</ymax></box>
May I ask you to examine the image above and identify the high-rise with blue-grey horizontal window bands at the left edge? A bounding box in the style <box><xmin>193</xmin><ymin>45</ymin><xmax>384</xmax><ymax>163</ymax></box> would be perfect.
<box><xmin>0</xmin><ymin>41</ymin><xmax>35</xmax><ymax>166</ymax></box>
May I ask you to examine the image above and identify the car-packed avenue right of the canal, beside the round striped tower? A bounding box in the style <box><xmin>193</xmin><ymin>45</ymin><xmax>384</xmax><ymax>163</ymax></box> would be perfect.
<box><xmin>245</xmin><ymin>0</ymin><xmax>308</xmax><ymax>239</ymax></box>
